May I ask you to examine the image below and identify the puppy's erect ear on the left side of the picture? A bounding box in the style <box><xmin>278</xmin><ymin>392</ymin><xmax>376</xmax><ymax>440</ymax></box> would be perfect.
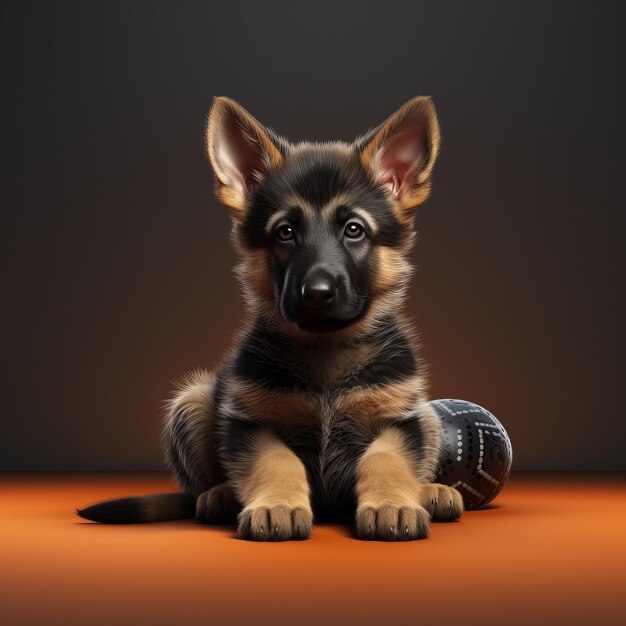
<box><xmin>207</xmin><ymin>98</ymin><xmax>283</xmax><ymax>220</ymax></box>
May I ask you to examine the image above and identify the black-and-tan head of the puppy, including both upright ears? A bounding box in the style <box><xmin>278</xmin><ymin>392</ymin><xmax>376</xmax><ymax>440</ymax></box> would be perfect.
<box><xmin>207</xmin><ymin>97</ymin><xmax>439</xmax><ymax>335</ymax></box>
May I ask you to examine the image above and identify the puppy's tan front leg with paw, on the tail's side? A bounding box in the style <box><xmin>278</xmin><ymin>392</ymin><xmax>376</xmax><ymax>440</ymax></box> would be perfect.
<box><xmin>232</xmin><ymin>431</ymin><xmax>313</xmax><ymax>541</ymax></box>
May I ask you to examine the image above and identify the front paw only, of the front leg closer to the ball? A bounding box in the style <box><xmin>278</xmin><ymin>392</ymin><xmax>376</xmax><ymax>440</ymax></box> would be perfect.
<box><xmin>355</xmin><ymin>504</ymin><xmax>430</xmax><ymax>541</ymax></box>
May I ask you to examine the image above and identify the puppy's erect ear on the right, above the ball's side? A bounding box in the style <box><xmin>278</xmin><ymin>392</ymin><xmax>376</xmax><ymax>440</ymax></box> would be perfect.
<box><xmin>356</xmin><ymin>96</ymin><xmax>439</xmax><ymax>219</ymax></box>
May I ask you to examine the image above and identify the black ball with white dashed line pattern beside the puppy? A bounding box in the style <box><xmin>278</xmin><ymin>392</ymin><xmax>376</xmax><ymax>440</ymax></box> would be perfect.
<box><xmin>430</xmin><ymin>400</ymin><xmax>513</xmax><ymax>509</ymax></box>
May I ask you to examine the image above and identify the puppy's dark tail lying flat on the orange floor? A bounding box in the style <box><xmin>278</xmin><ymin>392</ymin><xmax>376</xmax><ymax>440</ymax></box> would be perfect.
<box><xmin>76</xmin><ymin>492</ymin><xmax>196</xmax><ymax>524</ymax></box>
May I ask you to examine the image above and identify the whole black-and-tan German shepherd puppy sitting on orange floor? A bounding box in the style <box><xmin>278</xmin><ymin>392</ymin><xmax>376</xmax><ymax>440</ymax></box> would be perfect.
<box><xmin>78</xmin><ymin>97</ymin><xmax>463</xmax><ymax>541</ymax></box>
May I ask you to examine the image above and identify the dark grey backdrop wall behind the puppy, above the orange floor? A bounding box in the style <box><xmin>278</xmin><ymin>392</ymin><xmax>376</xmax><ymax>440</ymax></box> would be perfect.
<box><xmin>0</xmin><ymin>1</ymin><xmax>626</xmax><ymax>469</ymax></box>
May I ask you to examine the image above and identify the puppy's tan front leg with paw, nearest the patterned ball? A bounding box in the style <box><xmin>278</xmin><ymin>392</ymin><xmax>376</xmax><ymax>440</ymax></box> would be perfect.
<box><xmin>355</xmin><ymin>426</ymin><xmax>430</xmax><ymax>541</ymax></box>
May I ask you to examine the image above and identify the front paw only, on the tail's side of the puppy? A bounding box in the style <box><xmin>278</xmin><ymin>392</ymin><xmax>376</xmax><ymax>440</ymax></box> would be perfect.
<box><xmin>237</xmin><ymin>504</ymin><xmax>313</xmax><ymax>541</ymax></box>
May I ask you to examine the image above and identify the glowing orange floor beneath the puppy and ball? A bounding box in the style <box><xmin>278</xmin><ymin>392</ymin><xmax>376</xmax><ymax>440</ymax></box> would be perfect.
<box><xmin>0</xmin><ymin>473</ymin><xmax>626</xmax><ymax>626</ymax></box>
